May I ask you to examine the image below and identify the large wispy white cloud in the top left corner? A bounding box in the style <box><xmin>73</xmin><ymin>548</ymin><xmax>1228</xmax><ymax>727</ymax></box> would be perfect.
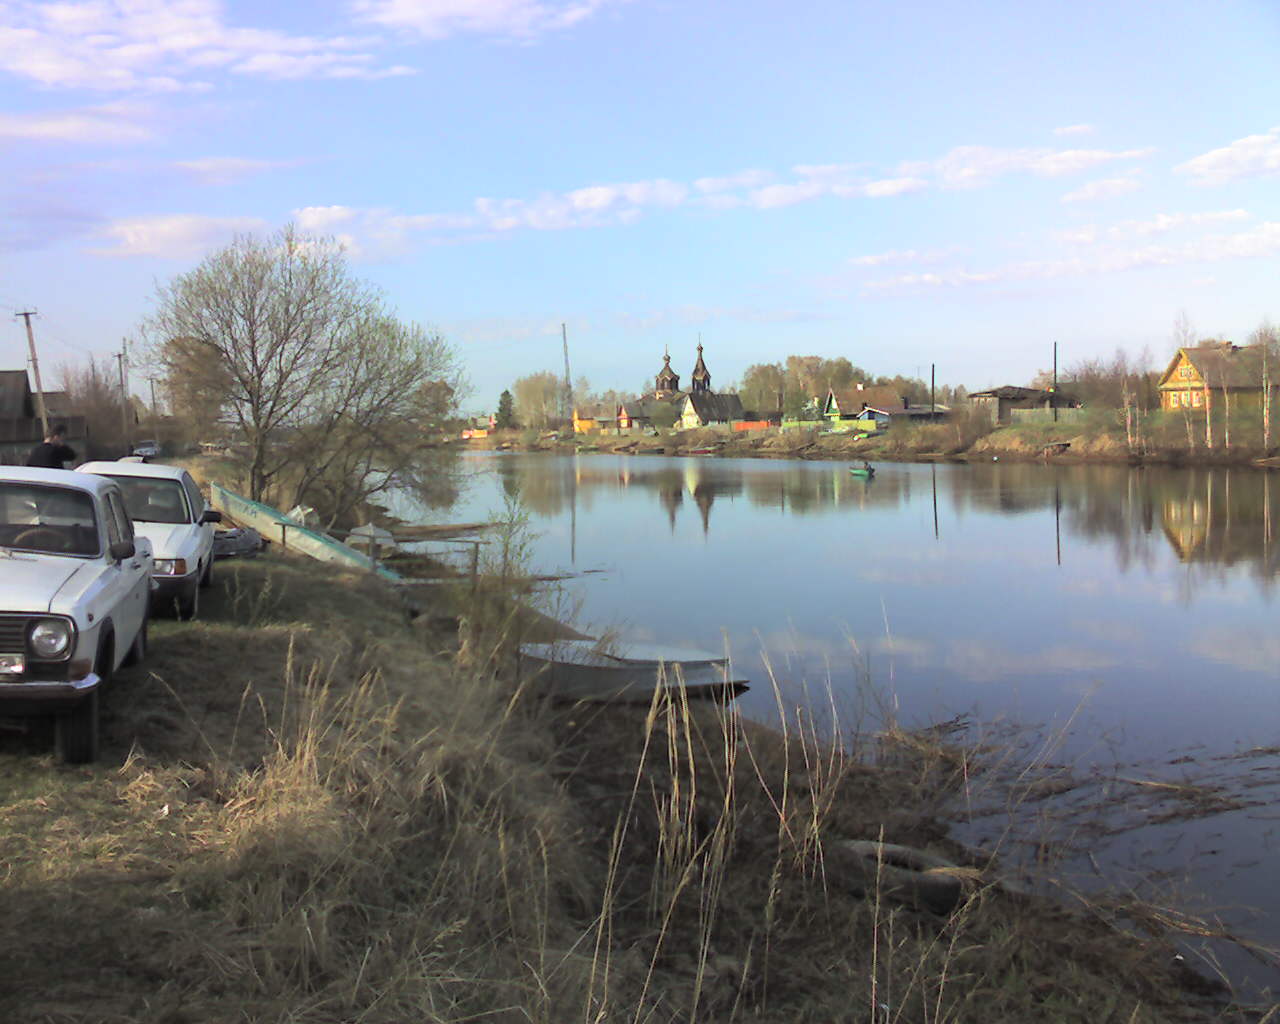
<box><xmin>0</xmin><ymin>0</ymin><xmax>412</xmax><ymax>92</ymax></box>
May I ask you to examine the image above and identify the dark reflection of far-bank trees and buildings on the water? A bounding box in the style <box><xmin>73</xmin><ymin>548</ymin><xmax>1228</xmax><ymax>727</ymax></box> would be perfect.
<box><xmin>495</xmin><ymin>456</ymin><xmax>1280</xmax><ymax>584</ymax></box>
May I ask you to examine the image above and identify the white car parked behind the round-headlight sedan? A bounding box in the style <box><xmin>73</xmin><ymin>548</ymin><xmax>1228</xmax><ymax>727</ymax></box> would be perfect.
<box><xmin>76</xmin><ymin>462</ymin><xmax>223</xmax><ymax>620</ymax></box>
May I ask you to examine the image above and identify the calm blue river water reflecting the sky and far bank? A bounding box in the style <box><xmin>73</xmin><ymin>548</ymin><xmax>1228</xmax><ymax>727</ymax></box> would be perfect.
<box><xmin>397</xmin><ymin>454</ymin><xmax>1280</xmax><ymax>984</ymax></box>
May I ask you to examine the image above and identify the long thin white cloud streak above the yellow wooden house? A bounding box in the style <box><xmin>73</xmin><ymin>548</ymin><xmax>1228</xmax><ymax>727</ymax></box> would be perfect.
<box><xmin>863</xmin><ymin>221</ymin><xmax>1280</xmax><ymax>293</ymax></box>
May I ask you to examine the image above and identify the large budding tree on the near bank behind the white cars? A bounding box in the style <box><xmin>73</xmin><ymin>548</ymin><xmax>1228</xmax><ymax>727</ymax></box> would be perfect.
<box><xmin>147</xmin><ymin>227</ymin><xmax>461</xmax><ymax>511</ymax></box>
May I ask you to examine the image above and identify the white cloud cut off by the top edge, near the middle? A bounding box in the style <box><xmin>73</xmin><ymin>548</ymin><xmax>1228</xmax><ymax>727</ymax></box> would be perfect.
<box><xmin>355</xmin><ymin>0</ymin><xmax>617</xmax><ymax>40</ymax></box>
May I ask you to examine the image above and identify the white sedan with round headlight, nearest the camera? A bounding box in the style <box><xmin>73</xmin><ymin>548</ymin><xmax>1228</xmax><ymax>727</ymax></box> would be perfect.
<box><xmin>0</xmin><ymin>466</ymin><xmax>152</xmax><ymax>763</ymax></box>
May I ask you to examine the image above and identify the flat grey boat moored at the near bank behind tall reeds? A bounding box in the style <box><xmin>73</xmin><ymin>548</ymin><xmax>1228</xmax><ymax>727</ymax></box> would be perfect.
<box><xmin>520</xmin><ymin>639</ymin><xmax>748</xmax><ymax>704</ymax></box>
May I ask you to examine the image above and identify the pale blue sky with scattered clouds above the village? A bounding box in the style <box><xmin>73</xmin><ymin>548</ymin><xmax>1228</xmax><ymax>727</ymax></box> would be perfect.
<box><xmin>0</xmin><ymin>0</ymin><xmax>1280</xmax><ymax>410</ymax></box>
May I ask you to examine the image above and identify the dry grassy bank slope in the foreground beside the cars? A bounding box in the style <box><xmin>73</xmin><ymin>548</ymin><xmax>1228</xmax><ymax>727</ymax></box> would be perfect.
<box><xmin>0</xmin><ymin>557</ymin><xmax>1239</xmax><ymax>1024</ymax></box>
